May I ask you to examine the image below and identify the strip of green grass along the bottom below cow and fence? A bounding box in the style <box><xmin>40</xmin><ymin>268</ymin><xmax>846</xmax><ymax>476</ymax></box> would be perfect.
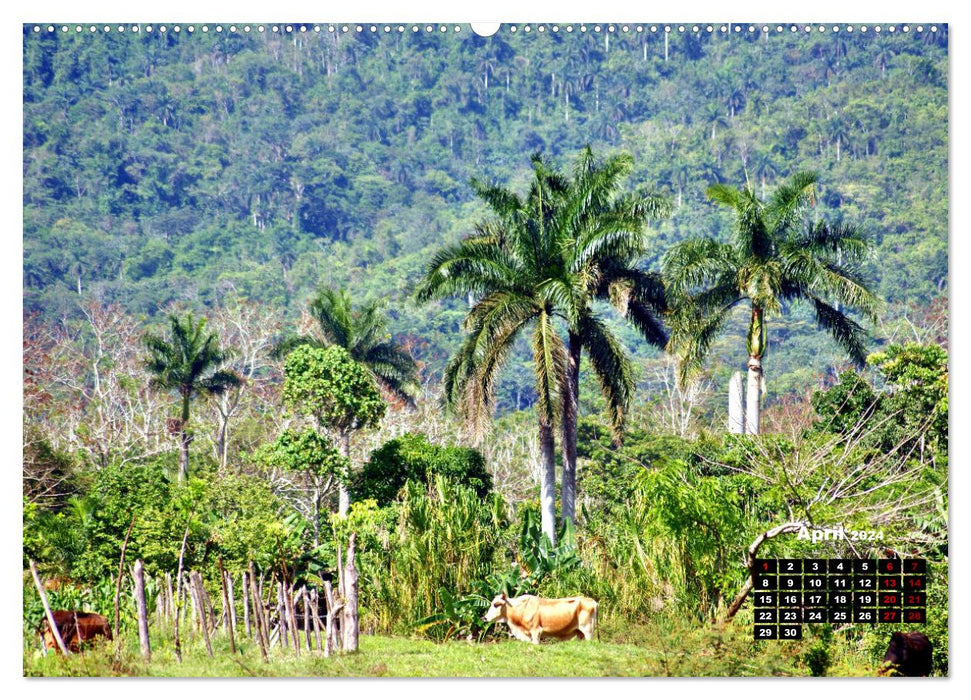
<box><xmin>24</xmin><ymin>626</ymin><xmax>875</xmax><ymax>678</ymax></box>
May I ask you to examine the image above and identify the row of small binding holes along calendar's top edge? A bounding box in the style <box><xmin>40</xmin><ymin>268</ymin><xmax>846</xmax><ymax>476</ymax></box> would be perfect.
<box><xmin>32</xmin><ymin>24</ymin><xmax>938</xmax><ymax>34</ymax></box>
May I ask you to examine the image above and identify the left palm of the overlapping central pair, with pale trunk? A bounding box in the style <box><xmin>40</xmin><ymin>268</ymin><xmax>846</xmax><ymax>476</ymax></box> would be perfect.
<box><xmin>415</xmin><ymin>163</ymin><xmax>566</xmax><ymax>542</ymax></box>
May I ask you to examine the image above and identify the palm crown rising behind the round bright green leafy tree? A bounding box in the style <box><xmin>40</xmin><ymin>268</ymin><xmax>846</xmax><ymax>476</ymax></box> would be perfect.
<box><xmin>274</xmin><ymin>287</ymin><xmax>420</xmax><ymax>405</ymax></box>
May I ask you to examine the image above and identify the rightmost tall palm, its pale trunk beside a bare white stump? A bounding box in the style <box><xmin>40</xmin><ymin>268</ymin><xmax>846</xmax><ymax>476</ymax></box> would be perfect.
<box><xmin>662</xmin><ymin>172</ymin><xmax>880</xmax><ymax>434</ymax></box>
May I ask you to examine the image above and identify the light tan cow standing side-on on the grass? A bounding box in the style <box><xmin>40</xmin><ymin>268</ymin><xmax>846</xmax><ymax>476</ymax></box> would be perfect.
<box><xmin>485</xmin><ymin>593</ymin><xmax>598</xmax><ymax>644</ymax></box>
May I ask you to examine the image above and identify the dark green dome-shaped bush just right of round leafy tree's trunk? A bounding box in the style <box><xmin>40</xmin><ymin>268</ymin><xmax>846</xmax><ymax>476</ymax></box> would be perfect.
<box><xmin>351</xmin><ymin>433</ymin><xmax>492</xmax><ymax>505</ymax></box>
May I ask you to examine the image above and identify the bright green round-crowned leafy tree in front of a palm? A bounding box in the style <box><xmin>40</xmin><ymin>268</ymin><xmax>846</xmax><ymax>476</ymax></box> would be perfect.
<box><xmin>283</xmin><ymin>345</ymin><xmax>386</xmax><ymax>517</ymax></box>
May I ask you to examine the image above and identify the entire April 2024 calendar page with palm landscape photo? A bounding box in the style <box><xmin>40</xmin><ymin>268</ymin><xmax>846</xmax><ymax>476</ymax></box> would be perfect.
<box><xmin>20</xmin><ymin>16</ymin><xmax>951</xmax><ymax>683</ymax></box>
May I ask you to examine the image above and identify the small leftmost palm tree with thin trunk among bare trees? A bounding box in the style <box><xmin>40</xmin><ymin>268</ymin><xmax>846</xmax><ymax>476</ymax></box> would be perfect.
<box><xmin>143</xmin><ymin>314</ymin><xmax>241</xmax><ymax>481</ymax></box>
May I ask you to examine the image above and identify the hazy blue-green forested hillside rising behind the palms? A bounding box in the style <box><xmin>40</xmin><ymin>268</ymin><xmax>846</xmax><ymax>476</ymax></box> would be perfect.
<box><xmin>24</xmin><ymin>25</ymin><xmax>948</xmax><ymax>409</ymax></box>
